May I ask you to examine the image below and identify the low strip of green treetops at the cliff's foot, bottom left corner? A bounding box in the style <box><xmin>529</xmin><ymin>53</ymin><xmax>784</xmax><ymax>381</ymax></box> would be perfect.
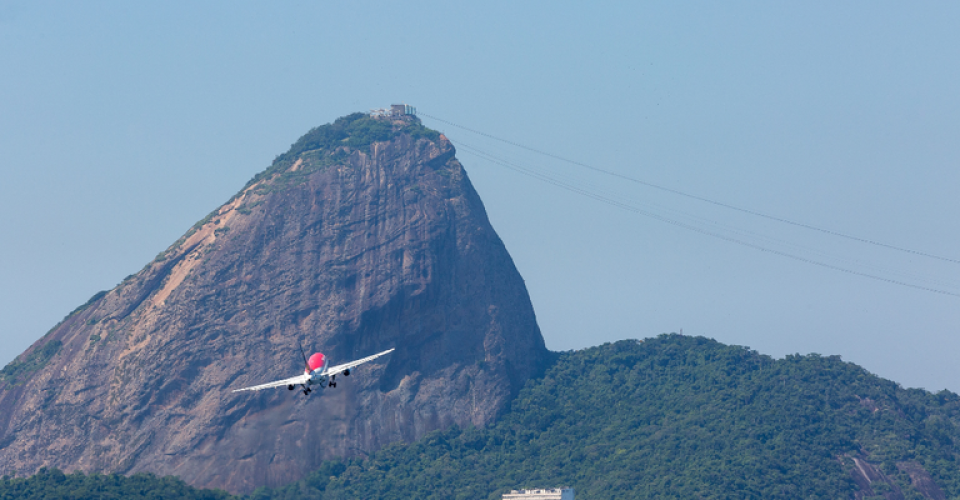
<box><xmin>0</xmin><ymin>469</ymin><xmax>231</xmax><ymax>500</ymax></box>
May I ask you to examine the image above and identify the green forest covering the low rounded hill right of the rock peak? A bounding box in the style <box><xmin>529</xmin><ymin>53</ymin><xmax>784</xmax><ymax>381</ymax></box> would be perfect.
<box><xmin>7</xmin><ymin>335</ymin><xmax>960</xmax><ymax>500</ymax></box>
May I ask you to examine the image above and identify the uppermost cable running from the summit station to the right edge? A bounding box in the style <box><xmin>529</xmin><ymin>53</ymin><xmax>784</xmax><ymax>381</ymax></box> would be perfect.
<box><xmin>419</xmin><ymin>113</ymin><xmax>960</xmax><ymax>264</ymax></box>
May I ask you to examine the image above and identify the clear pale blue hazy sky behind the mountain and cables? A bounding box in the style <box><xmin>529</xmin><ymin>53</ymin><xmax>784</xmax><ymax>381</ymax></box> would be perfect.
<box><xmin>0</xmin><ymin>0</ymin><xmax>960</xmax><ymax>391</ymax></box>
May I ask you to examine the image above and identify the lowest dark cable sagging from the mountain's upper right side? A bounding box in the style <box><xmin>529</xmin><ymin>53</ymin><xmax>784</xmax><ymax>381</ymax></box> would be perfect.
<box><xmin>454</xmin><ymin>143</ymin><xmax>960</xmax><ymax>297</ymax></box>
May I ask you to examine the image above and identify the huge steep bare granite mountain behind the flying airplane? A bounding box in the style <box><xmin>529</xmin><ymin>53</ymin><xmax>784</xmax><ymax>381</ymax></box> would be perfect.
<box><xmin>0</xmin><ymin>114</ymin><xmax>548</xmax><ymax>492</ymax></box>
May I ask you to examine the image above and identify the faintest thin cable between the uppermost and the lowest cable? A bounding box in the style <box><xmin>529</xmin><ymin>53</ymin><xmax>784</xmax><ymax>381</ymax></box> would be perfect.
<box><xmin>452</xmin><ymin>139</ymin><xmax>957</xmax><ymax>287</ymax></box>
